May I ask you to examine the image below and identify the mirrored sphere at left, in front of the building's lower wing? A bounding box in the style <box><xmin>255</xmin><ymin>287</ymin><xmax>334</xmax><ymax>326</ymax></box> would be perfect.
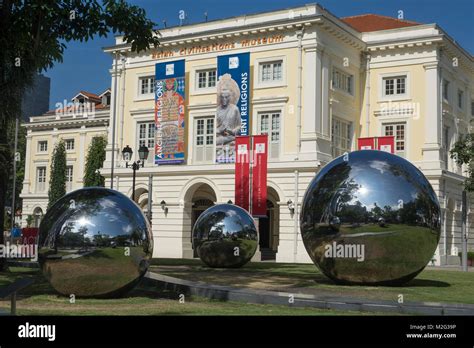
<box><xmin>38</xmin><ymin>187</ymin><xmax>152</xmax><ymax>297</ymax></box>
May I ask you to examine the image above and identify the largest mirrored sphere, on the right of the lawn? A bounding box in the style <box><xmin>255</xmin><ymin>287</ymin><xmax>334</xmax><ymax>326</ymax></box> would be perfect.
<box><xmin>300</xmin><ymin>150</ymin><xmax>440</xmax><ymax>285</ymax></box>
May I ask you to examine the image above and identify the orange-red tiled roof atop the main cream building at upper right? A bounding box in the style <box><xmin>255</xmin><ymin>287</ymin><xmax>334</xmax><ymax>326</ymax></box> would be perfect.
<box><xmin>341</xmin><ymin>13</ymin><xmax>421</xmax><ymax>32</ymax></box>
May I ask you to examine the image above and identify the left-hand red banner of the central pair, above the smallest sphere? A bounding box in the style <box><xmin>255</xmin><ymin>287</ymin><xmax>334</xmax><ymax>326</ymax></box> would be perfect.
<box><xmin>235</xmin><ymin>136</ymin><xmax>250</xmax><ymax>211</ymax></box>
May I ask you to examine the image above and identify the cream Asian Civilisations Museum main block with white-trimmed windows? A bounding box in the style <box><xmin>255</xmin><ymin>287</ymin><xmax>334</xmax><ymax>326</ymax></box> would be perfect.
<box><xmin>23</xmin><ymin>4</ymin><xmax>474</xmax><ymax>265</ymax></box>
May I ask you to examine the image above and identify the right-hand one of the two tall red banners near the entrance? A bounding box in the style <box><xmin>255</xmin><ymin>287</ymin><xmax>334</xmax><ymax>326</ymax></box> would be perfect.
<box><xmin>251</xmin><ymin>134</ymin><xmax>268</xmax><ymax>217</ymax></box>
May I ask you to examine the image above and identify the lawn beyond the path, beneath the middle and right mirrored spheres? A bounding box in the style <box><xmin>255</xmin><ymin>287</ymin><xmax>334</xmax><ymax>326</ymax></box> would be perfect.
<box><xmin>150</xmin><ymin>259</ymin><xmax>474</xmax><ymax>304</ymax></box>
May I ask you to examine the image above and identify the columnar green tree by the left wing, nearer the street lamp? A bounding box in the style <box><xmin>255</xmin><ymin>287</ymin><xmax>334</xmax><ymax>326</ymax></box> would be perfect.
<box><xmin>84</xmin><ymin>136</ymin><xmax>107</xmax><ymax>187</ymax></box>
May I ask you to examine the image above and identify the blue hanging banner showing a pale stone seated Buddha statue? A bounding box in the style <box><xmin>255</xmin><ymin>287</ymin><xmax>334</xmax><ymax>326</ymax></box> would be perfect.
<box><xmin>216</xmin><ymin>52</ymin><xmax>250</xmax><ymax>163</ymax></box>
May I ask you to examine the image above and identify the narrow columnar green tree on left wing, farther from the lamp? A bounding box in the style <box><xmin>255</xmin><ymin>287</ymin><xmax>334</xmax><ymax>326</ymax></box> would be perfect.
<box><xmin>48</xmin><ymin>140</ymin><xmax>66</xmax><ymax>209</ymax></box>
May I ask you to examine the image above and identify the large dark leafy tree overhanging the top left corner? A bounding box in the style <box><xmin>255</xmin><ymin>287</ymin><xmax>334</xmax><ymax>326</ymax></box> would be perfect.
<box><xmin>0</xmin><ymin>0</ymin><xmax>159</xmax><ymax>271</ymax></box>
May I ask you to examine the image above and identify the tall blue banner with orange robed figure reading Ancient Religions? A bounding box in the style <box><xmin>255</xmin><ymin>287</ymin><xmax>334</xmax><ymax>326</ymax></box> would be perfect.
<box><xmin>155</xmin><ymin>59</ymin><xmax>186</xmax><ymax>164</ymax></box>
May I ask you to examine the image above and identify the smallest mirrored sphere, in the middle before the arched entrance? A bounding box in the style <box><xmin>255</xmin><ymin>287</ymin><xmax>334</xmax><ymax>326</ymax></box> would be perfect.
<box><xmin>193</xmin><ymin>204</ymin><xmax>258</xmax><ymax>268</ymax></box>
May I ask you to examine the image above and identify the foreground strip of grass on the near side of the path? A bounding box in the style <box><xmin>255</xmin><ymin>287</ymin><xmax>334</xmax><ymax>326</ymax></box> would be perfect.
<box><xmin>0</xmin><ymin>267</ymin><xmax>386</xmax><ymax>315</ymax></box>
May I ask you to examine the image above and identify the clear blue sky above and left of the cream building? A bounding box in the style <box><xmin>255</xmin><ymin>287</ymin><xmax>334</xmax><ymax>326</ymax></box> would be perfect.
<box><xmin>45</xmin><ymin>0</ymin><xmax>474</xmax><ymax>109</ymax></box>
